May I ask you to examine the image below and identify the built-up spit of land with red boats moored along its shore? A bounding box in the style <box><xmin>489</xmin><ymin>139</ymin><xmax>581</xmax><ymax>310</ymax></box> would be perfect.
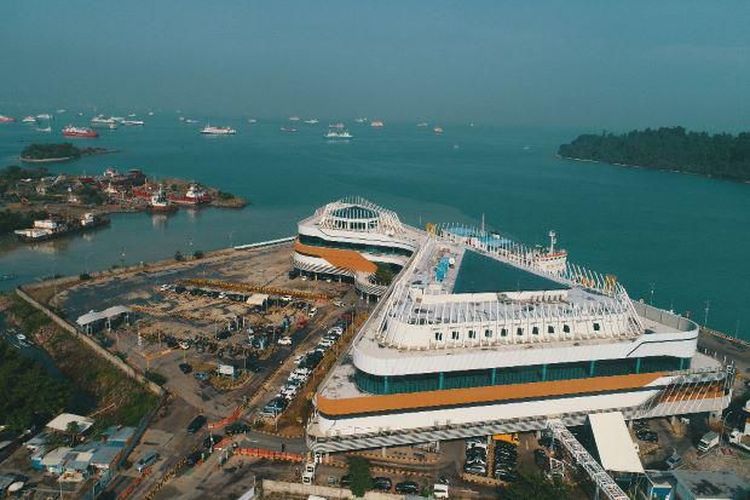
<box><xmin>0</xmin><ymin>165</ymin><xmax>247</xmax><ymax>242</ymax></box>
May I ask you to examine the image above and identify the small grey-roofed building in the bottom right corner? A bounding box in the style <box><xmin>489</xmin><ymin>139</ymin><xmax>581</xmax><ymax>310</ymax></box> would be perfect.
<box><xmin>672</xmin><ymin>470</ymin><xmax>750</xmax><ymax>500</ymax></box>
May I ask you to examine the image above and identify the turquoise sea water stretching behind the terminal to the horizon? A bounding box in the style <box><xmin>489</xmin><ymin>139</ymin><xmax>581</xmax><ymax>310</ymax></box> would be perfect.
<box><xmin>0</xmin><ymin>113</ymin><xmax>750</xmax><ymax>338</ymax></box>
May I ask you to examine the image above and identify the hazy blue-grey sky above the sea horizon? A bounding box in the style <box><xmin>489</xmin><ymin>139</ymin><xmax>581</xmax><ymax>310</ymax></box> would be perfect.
<box><xmin>0</xmin><ymin>0</ymin><xmax>750</xmax><ymax>130</ymax></box>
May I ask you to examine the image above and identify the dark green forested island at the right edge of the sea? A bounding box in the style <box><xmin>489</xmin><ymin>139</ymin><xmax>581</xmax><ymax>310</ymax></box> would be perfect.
<box><xmin>558</xmin><ymin>127</ymin><xmax>750</xmax><ymax>182</ymax></box>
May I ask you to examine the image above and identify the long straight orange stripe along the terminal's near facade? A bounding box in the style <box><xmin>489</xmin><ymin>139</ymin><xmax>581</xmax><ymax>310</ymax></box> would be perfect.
<box><xmin>316</xmin><ymin>372</ymin><xmax>664</xmax><ymax>416</ymax></box>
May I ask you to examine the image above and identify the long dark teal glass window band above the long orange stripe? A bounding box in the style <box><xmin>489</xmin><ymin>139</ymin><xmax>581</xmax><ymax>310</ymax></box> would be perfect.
<box><xmin>354</xmin><ymin>356</ymin><xmax>690</xmax><ymax>394</ymax></box>
